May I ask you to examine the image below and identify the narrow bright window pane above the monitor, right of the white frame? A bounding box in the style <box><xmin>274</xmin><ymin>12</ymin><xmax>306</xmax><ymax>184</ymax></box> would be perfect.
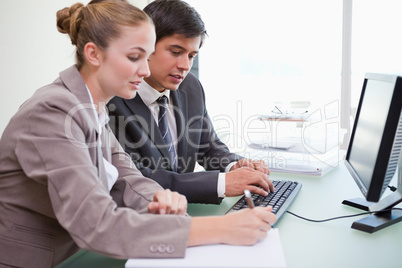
<box><xmin>351</xmin><ymin>0</ymin><xmax>402</xmax><ymax>115</ymax></box>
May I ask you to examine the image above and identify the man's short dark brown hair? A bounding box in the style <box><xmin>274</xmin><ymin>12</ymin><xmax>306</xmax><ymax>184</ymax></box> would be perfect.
<box><xmin>144</xmin><ymin>0</ymin><xmax>207</xmax><ymax>47</ymax></box>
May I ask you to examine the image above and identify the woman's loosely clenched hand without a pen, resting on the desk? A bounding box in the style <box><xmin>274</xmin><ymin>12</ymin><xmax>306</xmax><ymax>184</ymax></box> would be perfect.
<box><xmin>148</xmin><ymin>189</ymin><xmax>187</xmax><ymax>215</ymax></box>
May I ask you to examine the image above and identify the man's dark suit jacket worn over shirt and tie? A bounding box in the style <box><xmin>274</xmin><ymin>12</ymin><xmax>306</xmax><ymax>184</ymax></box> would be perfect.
<box><xmin>108</xmin><ymin>73</ymin><xmax>241</xmax><ymax>203</ymax></box>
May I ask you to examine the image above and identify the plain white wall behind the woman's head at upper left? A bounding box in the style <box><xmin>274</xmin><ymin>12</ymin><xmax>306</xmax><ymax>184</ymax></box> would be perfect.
<box><xmin>0</xmin><ymin>0</ymin><xmax>149</xmax><ymax>135</ymax></box>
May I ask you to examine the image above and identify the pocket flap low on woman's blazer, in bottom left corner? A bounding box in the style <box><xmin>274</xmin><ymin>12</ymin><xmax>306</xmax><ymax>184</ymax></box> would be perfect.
<box><xmin>0</xmin><ymin>237</ymin><xmax>53</xmax><ymax>267</ymax></box>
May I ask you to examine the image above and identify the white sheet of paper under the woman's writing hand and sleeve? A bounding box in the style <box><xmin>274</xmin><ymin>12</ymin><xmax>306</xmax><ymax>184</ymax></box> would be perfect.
<box><xmin>125</xmin><ymin>228</ymin><xmax>286</xmax><ymax>268</ymax></box>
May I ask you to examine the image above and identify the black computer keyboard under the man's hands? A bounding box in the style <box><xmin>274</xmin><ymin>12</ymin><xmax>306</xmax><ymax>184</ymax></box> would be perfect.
<box><xmin>226</xmin><ymin>180</ymin><xmax>302</xmax><ymax>223</ymax></box>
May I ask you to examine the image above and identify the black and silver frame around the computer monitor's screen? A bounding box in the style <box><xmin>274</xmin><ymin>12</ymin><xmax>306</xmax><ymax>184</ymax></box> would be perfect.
<box><xmin>345</xmin><ymin>73</ymin><xmax>402</xmax><ymax>202</ymax></box>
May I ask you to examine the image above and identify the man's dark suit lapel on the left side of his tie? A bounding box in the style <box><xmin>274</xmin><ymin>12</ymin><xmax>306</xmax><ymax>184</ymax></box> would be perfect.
<box><xmin>123</xmin><ymin>94</ymin><xmax>170</xmax><ymax>161</ymax></box>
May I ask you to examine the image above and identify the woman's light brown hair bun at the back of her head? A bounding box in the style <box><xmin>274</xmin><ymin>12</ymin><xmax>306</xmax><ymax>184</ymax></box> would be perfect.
<box><xmin>56</xmin><ymin>3</ymin><xmax>85</xmax><ymax>45</ymax></box>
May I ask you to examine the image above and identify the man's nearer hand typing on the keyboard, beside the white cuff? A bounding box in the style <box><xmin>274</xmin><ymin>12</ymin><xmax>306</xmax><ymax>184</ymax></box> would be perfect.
<box><xmin>225</xmin><ymin>167</ymin><xmax>275</xmax><ymax>196</ymax></box>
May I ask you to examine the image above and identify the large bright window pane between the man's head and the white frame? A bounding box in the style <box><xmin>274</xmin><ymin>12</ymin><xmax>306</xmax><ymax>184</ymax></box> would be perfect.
<box><xmin>187</xmin><ymin>0</ymin><xmax>342</xmax><ymax>150</ymax></box>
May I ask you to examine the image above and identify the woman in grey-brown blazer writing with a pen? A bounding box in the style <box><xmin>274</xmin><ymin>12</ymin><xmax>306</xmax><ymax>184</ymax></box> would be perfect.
<box><xmin>0</xmin><ymin>0</ymin><xmax>276</xmax><ymax>267</ymax></box>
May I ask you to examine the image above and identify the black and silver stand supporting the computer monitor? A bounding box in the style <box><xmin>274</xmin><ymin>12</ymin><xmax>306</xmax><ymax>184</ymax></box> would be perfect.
<box><xmin>342</xmin><ymin>158</ymin><xmax>402</xmax><ymax>233</ymax></box>
